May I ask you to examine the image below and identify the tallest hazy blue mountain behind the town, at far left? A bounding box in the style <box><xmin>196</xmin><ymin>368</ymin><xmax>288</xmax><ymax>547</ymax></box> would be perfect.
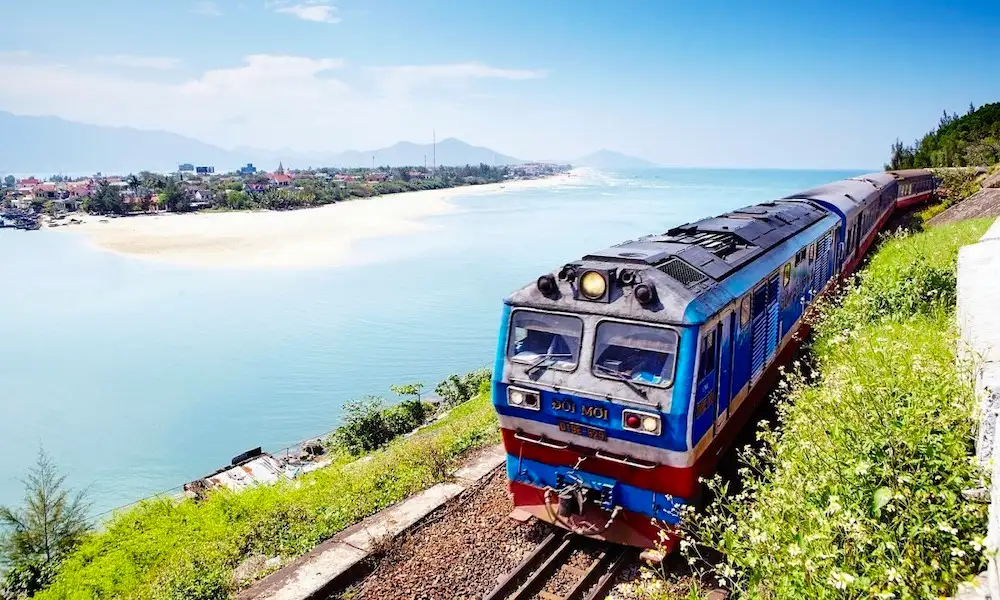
<box><xmin>0</xmin><ymin>111</ymin><xmax>252</xmax><ymax>175</ymax></box>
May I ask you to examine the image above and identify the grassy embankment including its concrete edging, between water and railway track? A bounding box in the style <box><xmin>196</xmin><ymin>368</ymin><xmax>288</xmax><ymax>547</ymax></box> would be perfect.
<box><xmin>28</xmin><ymin>393</ymin><xmax>499</xmax><ymax>600</ymax></box>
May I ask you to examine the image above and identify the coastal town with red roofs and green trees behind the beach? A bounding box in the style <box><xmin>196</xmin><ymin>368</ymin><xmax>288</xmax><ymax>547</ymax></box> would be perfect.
<box><xmin>0</xmin><ymin>163</ymin><xmax>569</xmax><ymax>229</ymax></box>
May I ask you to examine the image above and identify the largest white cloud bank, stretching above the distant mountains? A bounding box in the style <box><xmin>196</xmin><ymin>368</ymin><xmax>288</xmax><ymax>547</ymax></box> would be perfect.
<box><xmin>0</xmin><ymin>55</ymin><xmax>540</xmax><ymax>151</ymax></box>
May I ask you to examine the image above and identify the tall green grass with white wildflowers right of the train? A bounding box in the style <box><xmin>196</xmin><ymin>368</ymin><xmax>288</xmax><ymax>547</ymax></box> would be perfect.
<box><xmin>632</xmin><ymin>220</ymin><xmax>989</xmax><ymax>599</ymax></box>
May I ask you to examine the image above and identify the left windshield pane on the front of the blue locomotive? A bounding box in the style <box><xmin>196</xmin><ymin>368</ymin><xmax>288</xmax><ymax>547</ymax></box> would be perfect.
<box><xmin>507</xmin><ymin>310</ymin><xmax>583</xmax><ymax>370</ymax></box>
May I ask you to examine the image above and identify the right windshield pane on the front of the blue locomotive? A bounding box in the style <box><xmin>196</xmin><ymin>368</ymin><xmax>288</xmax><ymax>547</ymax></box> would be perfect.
<box><xmin>594</xmin><ymin>321</ymin><xmax>677</xmax><ymax>387</ymax></box>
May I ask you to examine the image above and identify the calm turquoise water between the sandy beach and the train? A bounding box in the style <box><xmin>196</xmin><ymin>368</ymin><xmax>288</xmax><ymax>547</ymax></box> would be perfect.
<box><xmin>0</xmin><ymin>169</ymin><xmax>858</xmax><ymax>512</ymax></box>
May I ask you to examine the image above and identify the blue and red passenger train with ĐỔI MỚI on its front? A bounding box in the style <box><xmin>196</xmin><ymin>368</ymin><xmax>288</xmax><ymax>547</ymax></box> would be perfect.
<box><xmin>491</xmin><ymin>169</ymin><xmax>940</xmax><ymax>557</ymax></box>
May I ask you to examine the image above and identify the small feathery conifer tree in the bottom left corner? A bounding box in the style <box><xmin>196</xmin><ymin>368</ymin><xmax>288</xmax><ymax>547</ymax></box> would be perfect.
<box><xmin>0</xmin><ymin>449</ymin><xmax>89</xmax><ymax>597</ymax></box>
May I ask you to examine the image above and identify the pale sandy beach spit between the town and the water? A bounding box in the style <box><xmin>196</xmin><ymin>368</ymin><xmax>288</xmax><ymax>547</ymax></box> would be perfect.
<box><xmin>51</xmin><ymin>171</ymin><xmax>580</xmax><ymax>268</ymax></box>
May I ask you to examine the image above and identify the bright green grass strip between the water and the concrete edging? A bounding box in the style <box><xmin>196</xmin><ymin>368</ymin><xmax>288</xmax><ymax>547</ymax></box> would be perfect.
<box><xmin>36</xmin><ymin>393</ymin><xmax>499</xmax><ymax>600</ymax></box>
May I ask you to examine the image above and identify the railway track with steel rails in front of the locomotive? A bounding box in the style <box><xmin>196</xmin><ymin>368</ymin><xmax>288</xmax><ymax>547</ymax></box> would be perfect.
<box><xmin>483</xmin><ymin>531</ymin><xmax>630</xmax><ymax>600</ymax></box>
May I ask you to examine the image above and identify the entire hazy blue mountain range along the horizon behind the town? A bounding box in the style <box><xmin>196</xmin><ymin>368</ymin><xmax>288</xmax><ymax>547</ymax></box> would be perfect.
<box><xmin>0</xmin><ymin>111</ymin><xmax>656</xmax><ymax>176</ymax></box>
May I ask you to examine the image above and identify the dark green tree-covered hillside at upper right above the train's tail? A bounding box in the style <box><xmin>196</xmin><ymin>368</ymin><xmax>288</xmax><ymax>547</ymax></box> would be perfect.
<box><xmin>885</xmin><ymin>102</ymin><xmax>1000</xmax><ymax>170</ymax></box>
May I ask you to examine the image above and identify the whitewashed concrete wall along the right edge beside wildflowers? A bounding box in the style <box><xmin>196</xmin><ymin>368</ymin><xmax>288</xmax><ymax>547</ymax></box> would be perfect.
<box><xmin>958</xmin><ymin>219</ymin><xmax>1000</xmax><ymax>600</ymax></box>
